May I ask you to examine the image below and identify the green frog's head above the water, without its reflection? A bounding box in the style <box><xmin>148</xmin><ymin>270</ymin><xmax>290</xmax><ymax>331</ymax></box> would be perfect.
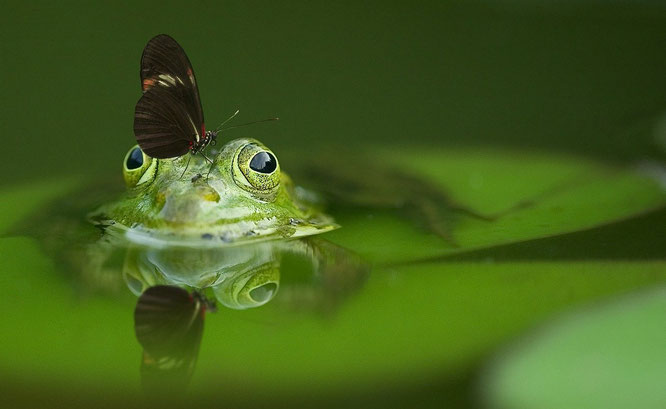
<box><xmin>91</xmin><ymin>138</ymin><xmax>338</xmax><ymax>246</ymax></box>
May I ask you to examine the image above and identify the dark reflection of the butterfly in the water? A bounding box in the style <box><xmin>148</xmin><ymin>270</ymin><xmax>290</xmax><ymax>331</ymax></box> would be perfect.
<box><xmin>134</xmin><ymin>285</ymin><xmax>215</xmax><ymax>391</ymax></box>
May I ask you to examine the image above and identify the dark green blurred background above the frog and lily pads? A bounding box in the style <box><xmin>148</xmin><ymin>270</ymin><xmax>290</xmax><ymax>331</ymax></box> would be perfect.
<box><xmin>0</xmin><ymin>0</ymin><xmax>666</xmax><ymax>183</ymax></box>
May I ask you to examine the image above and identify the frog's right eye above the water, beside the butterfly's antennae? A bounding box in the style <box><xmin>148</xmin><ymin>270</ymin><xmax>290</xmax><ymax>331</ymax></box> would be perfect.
<box><xmin>234</xmin><ymin>142</ymin><xmax>280</xmax><ymax>201</ymax></box>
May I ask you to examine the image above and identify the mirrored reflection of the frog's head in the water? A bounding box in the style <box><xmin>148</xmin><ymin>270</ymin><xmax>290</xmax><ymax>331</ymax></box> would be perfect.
<box><xmin>122</xmin><ymin>238</ymin><xmax>368</xmax><ymax>312</ymax></box>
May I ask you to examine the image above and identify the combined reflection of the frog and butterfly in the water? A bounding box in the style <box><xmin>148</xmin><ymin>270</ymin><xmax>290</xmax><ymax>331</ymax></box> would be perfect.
<box><xmin>109</xmin><ymin>238</ymin><xmax>369</xmax><ymax>392</ymax></box>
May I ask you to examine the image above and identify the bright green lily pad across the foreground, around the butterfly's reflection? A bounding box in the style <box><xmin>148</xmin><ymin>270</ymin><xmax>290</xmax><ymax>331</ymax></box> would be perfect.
<box><xmin>0</xmin><ymin>231</ymin><xmax>666</xmax><ymax>399</ymax></box>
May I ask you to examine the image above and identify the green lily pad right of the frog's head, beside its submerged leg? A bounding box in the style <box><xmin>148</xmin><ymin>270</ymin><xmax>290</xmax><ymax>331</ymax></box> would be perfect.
<box><xmin>329</xmin><ymin>150</ymin><xmax>666</xmax><ymax>263</ymax></box>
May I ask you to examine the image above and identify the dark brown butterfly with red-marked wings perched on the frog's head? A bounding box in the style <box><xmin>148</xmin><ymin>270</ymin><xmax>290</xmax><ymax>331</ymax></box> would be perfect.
<box><xmin>134</xmin><ymin>34</ymin><xmax>218</xmax><ymax>159</ymax></box>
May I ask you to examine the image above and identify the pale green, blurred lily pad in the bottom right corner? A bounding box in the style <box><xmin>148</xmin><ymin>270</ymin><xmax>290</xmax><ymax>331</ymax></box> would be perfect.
<box><xmin>481</xmin><ymin>287</ymin><xmax>666</xmax><ymax>409</ymax></box>
